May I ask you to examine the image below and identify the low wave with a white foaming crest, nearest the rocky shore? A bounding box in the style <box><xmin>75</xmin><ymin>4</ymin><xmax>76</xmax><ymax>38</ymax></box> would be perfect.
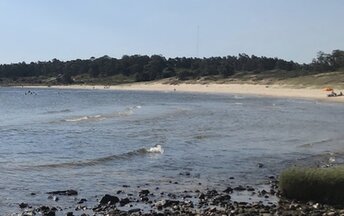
<box><xmin>34</xmin><ymin>145</ymin><xmax>164</xmax><ymax>168</ymax></box>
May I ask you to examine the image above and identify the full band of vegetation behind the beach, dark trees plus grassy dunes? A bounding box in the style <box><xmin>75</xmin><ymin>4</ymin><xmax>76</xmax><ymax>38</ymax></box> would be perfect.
<box><xmin>0</xmin><ymin>50</ymin><xmax>344</xmax><ymax>85</ymax></box>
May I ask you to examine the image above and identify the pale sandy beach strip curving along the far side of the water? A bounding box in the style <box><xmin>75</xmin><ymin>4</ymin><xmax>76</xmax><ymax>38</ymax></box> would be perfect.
<box><xmin>14</xmin><ymin>81</ymin><xmax>344</xmax><ymax>102</ymax></box>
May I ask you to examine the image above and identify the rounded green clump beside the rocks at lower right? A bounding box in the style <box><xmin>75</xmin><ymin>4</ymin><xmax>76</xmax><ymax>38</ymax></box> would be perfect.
<box><xmin>279</xmin><ymin>166</ymin><xmax>344</xmax><ymax>204</ymax></box>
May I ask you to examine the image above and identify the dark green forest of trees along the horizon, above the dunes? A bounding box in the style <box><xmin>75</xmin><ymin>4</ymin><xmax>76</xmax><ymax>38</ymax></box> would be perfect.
<box><xmin>0</xmin><ymin>50</ymin><xmax>344</xmax><ymax>84</ymax></box>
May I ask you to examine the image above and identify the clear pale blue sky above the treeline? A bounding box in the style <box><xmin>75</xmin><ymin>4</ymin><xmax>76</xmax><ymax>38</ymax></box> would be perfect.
<box><xmin>0</xmin><ymin>0</ymin><xmax>344</xmax><ymax>64</ymax></box>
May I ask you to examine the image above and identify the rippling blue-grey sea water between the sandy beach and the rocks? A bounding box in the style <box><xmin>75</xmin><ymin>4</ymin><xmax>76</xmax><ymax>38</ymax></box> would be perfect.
<box><xmin>0</xmin><ymin>88</ymin><xmax>344</xmax><ymax>215</ymax></box>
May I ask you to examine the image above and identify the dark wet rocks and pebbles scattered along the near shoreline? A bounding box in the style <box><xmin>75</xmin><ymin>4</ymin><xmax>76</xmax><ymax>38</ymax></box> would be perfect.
<box><xmin>17</xmin><ymin>177</ymin><xmax>344</xmax><ymax>216</ymax></box>
